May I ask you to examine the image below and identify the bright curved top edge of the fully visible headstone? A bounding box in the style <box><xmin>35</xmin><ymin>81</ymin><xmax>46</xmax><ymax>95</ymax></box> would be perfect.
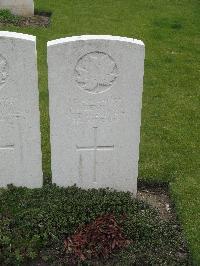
<box><xmin>47</xmin><ymin>35</ymin><xmax>144</xmax><ymax>47</ymax></box>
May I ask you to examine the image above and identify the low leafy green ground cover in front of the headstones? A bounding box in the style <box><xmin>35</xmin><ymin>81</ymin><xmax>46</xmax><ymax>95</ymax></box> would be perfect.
<box><xmin>0</xmin><ymin>185</ymin><xmax>190</xmax><ymax>265</ymax></box>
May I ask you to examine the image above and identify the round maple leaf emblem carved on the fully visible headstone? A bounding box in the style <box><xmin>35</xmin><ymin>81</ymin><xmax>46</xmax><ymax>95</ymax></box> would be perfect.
<box><xmin>74</xmin><ymin>51</ymin><xmax>118</xmax><ymax>93</ymax></box>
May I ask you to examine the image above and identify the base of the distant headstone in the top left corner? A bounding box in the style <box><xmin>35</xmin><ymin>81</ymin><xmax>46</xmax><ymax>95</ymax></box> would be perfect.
<box><xmin>0</xmin><ymin>0</ymin><xmax>34</xmax><ymax>17</ymax></box>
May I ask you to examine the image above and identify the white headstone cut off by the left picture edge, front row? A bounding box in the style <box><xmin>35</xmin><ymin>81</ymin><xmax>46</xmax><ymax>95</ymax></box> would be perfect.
<box><xmin>0</xmin><ymin>32</ymin><xmax>43</xmax><ymax>188</ymax></box>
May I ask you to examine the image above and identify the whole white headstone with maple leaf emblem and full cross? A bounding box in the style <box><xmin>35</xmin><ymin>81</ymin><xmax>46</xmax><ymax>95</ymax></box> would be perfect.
<box><xmin>48</xmin><ymin>36</ymin><xmax>145</xmax><ymax>194</ymax></box>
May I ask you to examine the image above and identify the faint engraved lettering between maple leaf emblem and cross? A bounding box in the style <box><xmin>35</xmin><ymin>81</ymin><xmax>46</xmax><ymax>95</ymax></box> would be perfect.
<box><xmin>67</xmin><ymin>96</ymin><xmax>125</xmax><ymax>123</ymax></box>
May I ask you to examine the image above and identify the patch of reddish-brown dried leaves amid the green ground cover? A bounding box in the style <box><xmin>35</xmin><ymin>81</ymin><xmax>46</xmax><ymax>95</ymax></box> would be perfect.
<box><xmin>64</xmin><ymin>214</ymin><xmax>130</xmax><ymax>261</ymax></box>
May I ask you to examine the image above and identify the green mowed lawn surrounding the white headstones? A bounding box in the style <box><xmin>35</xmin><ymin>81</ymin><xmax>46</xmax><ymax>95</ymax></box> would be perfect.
<box><xmin>0</xmin><ymin>0</ymin><xmax>200</xmax><ymax>265</ymax></box>
